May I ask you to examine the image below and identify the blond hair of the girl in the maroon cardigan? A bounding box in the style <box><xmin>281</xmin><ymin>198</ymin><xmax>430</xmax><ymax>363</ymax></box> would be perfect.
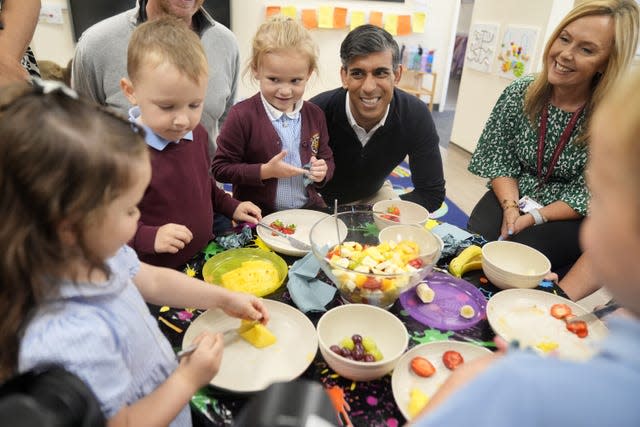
<box><xmin>245</xmin><ymin>15</ymin><xmax>318</xmax><ymax>78</ymax></box>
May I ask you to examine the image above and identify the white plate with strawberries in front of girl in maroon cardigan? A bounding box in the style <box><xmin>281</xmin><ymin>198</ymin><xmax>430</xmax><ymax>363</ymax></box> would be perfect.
<box><xmin>257</xmin><ymin>209</ymin><xmax>329</xmax><ymax>256</ymax></box>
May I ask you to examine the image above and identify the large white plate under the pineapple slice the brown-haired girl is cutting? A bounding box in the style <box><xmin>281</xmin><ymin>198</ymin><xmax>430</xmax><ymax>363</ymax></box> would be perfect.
<box><xmin>182</xmin><ymin>299</ymin><xmax>318</xmax><ymax>393</ymax></box>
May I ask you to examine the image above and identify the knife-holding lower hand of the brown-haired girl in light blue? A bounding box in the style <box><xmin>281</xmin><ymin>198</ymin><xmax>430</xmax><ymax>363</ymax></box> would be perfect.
<box><xmin>176</xmin><ymin>331</ymin><xmax>224</xmax><ymax>388</ymax></box>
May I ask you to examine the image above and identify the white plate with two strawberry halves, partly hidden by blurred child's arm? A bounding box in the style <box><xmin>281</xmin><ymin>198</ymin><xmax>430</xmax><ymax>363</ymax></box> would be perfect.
<box><xmin>391</xmin><ymin>341</ymin><xmax>491</xmax><ymax>421</ymax></box>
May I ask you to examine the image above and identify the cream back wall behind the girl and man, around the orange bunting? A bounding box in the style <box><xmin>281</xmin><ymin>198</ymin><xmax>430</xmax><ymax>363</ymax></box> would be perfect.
<box><xmin>32</xmin><ymin>0</ymin><xmax>460</xmax><ymax>103</ymax></box>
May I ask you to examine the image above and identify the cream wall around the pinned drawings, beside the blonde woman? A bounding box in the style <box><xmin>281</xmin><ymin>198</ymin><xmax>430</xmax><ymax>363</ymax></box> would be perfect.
<box><xmin>451</xmin><ymin>0</ymin><xmax>573</xmax><ymax>152</ymax></box>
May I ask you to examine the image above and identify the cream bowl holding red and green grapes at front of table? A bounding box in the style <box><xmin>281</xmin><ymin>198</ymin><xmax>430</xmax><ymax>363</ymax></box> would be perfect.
<box><xmin>316</xmin><ymin>304</ymin><xmax>409</xmax><ymax>381</ymax></box>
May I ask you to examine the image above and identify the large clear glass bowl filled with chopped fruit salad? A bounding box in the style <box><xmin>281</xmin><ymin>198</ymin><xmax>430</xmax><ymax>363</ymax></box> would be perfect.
<box><xmin>309</xmin><ymin>211</ymin><xmax>441</xmax><ymax>308</ymax></box>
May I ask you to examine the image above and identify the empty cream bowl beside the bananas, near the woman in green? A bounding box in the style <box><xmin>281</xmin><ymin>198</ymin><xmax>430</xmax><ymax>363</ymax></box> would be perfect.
<box><xmin>482</xmin><ymin>240</ymin><xmax>551</xmax><ymax>289</ymax></box>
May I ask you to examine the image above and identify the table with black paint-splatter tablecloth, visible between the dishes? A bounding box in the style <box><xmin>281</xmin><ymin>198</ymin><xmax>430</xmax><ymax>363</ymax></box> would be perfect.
<box><xmin>152</xmin><ymin>226</ymin><xmax>565</xmax><ymax>427</ymax></box>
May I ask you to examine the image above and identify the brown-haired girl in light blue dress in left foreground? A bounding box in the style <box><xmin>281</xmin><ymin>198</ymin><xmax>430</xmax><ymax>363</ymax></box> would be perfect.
<box><xmin>0</xmin><ymin>81</ymin><xmax>269</xmax><ymax>427</ymax></box>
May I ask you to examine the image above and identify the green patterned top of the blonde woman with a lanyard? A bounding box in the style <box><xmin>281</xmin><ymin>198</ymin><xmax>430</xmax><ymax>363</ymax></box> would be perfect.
<box><xmin>469</xmin><ymin>76</ymin><xmax>589</xmax><ymax>215</ymax></box>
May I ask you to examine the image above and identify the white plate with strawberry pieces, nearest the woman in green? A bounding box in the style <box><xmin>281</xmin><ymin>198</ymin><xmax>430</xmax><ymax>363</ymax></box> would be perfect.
<box><xmin>487</xmin><ymin>289</ymin><xmax>607</xmax><ymax>360</ymax></box>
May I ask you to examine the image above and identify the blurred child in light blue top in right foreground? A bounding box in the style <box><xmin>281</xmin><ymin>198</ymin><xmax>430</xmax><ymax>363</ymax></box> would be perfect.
<box><xmin>414</xmin><ymin>67</ymin><xmax>640</xmax><ymax>427</ymax></box>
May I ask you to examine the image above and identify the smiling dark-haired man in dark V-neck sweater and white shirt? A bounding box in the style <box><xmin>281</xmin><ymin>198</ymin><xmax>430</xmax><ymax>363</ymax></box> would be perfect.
<box><xmin>311</xmin><ymin>25</ymin><xmax>445</xmax><ymax>211</ymax></box>
